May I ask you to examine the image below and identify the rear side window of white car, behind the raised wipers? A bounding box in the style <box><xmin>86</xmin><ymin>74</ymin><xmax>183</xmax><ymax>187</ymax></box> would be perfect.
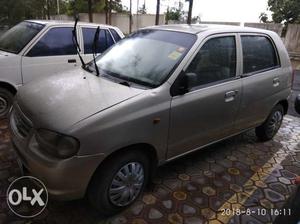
<box><xmin>82</xmin><ymin>28</ymin><xmax>114</xmax><ymax>54</ymax></box>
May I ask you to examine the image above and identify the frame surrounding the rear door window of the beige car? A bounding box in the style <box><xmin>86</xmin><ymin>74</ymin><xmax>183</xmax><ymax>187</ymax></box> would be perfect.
<box><xmin>238</xmin><ymin>32</ymin><xmax>281</xmax><ymax>78</ymax></box>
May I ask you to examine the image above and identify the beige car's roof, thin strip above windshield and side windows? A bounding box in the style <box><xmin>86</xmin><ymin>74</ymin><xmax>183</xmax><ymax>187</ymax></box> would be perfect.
<box><xmin>146</xmin><ymin>24</ymin><xmax>276</xmax><ymax>34</ymax></box>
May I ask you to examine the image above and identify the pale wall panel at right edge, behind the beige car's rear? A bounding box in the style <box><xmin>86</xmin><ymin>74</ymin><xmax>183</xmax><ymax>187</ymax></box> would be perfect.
<box><xmin>285</xmin><ymin>24</ymin><xmax>300</xmax><ymax>59</ymax></box>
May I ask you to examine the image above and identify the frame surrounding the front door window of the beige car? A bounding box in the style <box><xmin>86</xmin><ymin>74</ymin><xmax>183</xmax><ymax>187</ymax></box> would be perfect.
<box><xmin>170</xmin><ymin>32</ymin><xmax>240</xmax><ymax>93</ymax></box>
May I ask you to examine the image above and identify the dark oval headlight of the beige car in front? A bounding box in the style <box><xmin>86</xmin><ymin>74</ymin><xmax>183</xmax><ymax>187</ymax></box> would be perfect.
<box><xmin>36</xmin><ymin>129</ymin><xmax>79</xmax><ymax>159</ymax></box>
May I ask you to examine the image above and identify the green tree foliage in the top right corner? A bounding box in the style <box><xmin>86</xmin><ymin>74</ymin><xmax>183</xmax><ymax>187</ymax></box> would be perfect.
<box><xmin>268</xmin><ymin>0</ymin><xmax>300</xmax><ymax>24</ymax></box>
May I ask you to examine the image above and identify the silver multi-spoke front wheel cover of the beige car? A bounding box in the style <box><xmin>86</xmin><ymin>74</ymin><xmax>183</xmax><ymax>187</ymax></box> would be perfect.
<box><xmin>109</xmin><ymin>162</ymin><xmax>144</xmax><ymax>206</ymax></box>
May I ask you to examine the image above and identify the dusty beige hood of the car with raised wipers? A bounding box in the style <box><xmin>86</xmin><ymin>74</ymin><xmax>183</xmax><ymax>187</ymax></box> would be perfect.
<box><xmin>17</xmin><ymin>69</ymin><xmax>144</xmax><ymax>131</ymax></box>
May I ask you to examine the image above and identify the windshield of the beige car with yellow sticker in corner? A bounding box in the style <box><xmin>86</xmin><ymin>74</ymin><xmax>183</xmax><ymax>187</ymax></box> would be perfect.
<box><xmin>94</xmin><ymin>29</ymin><xmax>197</xmax><ymax>87</ymax></box>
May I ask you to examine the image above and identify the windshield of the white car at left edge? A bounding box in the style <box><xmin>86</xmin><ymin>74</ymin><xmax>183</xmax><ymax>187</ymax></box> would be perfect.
<box><xmin>0</xmin><ymin>22</ymin><xmax>44</xmax><ymax>54</ymax></box>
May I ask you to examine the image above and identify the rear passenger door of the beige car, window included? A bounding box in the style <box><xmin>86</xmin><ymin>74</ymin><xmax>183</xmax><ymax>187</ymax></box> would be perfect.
<box><xmin>236</xmin><ymin>33</ymin><xmax>286</xmax><ymax>131</ymax></box>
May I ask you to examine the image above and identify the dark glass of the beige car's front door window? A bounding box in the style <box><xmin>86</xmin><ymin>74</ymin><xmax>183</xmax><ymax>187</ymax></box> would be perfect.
<box><xmin>186</xmin><ymin>37</ymin><xmax>236</xmax><ymax>88</ymax></box>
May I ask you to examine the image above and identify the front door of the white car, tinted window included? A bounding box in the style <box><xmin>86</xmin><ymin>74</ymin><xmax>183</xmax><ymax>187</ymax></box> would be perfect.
<box><xmin>22</xmin><ymin>27</ymin><xmax>80</xmax><ymax>83</ymax></box>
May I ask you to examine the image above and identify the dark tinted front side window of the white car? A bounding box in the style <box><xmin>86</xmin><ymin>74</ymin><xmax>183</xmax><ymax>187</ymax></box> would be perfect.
<box><xmin>27</xmin><ymin>27</ymin><xmax>76</xmax><ymax>57</ymax></box>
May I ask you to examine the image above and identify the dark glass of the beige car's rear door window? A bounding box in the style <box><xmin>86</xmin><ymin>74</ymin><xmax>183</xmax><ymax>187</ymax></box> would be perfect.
<box><xmin>242</xmin><ymin>36</ymin><xmax>279</xmax><ymax>73</ymax></box>
